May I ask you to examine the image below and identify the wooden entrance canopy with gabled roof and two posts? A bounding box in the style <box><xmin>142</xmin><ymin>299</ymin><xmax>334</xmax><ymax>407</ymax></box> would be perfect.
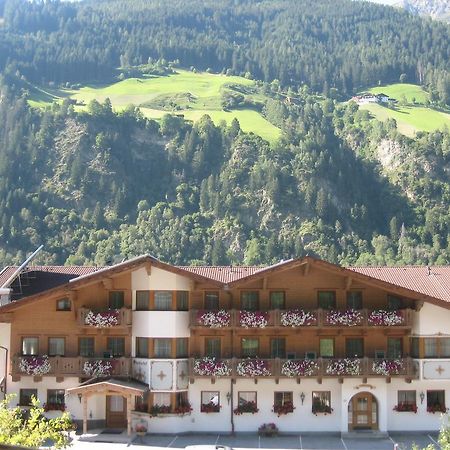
<box><xmin>67</xmin><ymin>378</ymin><xmax>148</xmax><ymax>435</ymax></box>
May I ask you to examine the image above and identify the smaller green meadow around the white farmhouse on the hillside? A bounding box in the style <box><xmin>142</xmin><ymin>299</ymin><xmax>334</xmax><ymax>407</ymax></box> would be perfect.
<box><xmin>360</xmin><ymin>83</ymin><xmax>450</xmax><ymax>137</ymax></box>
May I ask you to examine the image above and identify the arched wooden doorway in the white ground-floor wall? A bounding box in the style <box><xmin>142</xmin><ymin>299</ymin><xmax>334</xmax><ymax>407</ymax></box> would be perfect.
<box><xmin>348</xmin><ymin>392</ymin><xmax>378</xmax><ymax>431</ymax></box>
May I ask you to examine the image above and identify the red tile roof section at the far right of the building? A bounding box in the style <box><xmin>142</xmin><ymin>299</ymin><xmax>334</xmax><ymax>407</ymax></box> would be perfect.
<box><xmin>349</xmin><ymin>266</ymin><xmax>450</xmax><ymax>303</ymax></box>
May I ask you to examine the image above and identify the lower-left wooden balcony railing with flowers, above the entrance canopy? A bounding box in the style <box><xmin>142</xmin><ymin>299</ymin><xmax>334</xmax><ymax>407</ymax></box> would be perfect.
<box><xmin>11</xmin><ymin>356</ymin><xmax>131</xmax><ymax>381</ymax></box>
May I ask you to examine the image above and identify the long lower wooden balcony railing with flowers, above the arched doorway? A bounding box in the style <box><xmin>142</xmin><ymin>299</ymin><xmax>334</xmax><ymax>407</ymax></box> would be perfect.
<box><xmin>189</xmin><ymin>358</ymin><xmax>419</xmax><ymax>379</ymax></box>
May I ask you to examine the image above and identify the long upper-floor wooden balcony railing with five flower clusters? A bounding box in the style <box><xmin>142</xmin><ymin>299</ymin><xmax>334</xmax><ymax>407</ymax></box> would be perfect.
<box><xmin>190</xmin><ymin>309</ymin><xmax>412</xmax><ymax>329</ymax></box>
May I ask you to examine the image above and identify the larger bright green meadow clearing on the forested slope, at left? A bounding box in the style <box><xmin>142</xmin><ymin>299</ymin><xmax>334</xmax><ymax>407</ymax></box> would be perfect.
<box><xmin>29</xmin><ymin>70</ymin><xmax>281</xmax><ymax>142</ymax></box>
